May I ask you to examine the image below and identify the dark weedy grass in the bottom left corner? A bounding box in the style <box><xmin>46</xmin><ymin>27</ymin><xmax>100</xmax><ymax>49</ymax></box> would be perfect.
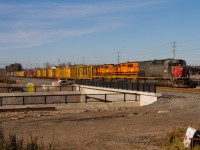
<box><xmin>0</xmin><ymin>129</ymin><xmax>54</xmax><ymax>150</ymax></box>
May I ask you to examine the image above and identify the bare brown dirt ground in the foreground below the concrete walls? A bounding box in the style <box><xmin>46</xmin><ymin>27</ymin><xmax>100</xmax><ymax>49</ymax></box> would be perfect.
<box><xmin>0</xmin><ymin>79</ymin><xmax>200</xmax><ymax>150</ymax></box>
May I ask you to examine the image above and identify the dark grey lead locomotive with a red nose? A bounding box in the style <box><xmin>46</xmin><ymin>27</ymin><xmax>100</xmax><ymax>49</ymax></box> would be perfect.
<box><xmin>138</xmin><ymin>59</ymin><xmax>192</xmax><ymax>87</ymax></box>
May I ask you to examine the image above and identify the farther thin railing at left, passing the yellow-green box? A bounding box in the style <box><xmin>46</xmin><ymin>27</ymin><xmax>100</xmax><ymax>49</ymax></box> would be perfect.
<box><xmin>0</xmin><ymin>85</ymin><xmax>80</xmax><ymax>93</ymax></box>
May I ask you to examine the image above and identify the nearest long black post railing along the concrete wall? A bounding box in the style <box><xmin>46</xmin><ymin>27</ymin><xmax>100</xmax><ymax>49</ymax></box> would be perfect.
<box><xmin>0</xmin><ymin>93</ymin><xmax>140</xmax><ymax>106</ymax></box>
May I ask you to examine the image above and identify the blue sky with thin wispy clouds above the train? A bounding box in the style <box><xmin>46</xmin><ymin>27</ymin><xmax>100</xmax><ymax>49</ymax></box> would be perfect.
<box><xmin>0</xmin><ymin>0</ymin><xmax>200</xmax><ymax>68</ymax></box>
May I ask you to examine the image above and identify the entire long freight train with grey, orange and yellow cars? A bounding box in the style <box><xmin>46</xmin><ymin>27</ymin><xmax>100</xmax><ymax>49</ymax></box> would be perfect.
<box><xmin>9</xmin><ymin>59</ymin><xmax>192</xmax><ymax>87</ymax></box>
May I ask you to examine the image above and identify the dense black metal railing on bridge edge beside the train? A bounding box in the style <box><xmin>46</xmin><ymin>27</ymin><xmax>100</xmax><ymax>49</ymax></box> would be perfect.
<box><xmin>75</xmin><ymin>80</ymin><xmax>156</xmax><ymax>93</ymax></box>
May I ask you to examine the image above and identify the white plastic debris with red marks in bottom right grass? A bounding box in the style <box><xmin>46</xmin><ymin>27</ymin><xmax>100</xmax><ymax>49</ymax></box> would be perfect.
<box><xmin>183</xmin><ymin>127</ymin><xmax>197</xmax><ymax>148</ymax></box>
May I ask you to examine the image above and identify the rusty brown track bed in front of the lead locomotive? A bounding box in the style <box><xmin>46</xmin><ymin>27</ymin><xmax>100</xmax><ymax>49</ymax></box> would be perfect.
<box><xmin>156</xmin><ymin>87</ymin><xmax>200</xmax><ymax>94</ymax></box>
